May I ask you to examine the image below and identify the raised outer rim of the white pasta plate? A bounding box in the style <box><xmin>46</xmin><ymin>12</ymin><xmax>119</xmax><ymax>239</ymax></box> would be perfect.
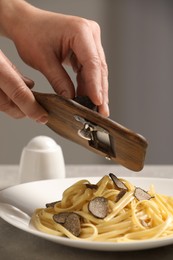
<box><xmin>0</xmin><ymin>175</ymin><xmax>173</xmax><ymax>251</ymax></box>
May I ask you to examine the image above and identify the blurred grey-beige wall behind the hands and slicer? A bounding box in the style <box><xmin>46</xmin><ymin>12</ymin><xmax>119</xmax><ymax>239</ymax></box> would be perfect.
<box><xmin>0</xmin><ymin>0</ymin><xmax>173</xmax><ymax>164</ymax></box>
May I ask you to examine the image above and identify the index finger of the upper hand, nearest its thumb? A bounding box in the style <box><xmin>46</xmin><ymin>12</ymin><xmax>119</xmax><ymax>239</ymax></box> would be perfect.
<box><xmin>71</xmin><ymin>20</ymin><xmax>102</xmax><ymax>105</ymax></box>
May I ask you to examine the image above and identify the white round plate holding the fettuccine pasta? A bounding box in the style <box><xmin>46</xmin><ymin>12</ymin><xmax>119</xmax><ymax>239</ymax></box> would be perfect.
<box><xmin>0</xmin><ymin>177</ymin><xmax>173</xmax><ymax>251</ymax></box>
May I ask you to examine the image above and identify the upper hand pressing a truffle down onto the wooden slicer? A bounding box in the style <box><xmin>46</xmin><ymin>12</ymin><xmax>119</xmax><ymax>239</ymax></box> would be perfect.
<box><xmin>0</xmin><ymin>0</ymin><xmax>109</xmax><ymax>116</ymax></box>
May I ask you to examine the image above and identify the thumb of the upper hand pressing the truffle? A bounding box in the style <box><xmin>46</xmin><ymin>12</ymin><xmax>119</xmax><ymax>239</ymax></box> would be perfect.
<box><xmin>40</xmin><ymin>54</ymin><xmax>75</xmax><ymax>98</ymax></box>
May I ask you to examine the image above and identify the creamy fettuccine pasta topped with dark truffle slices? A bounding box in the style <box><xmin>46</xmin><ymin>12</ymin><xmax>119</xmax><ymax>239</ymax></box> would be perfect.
<box><xmin>32</xmin><ymin>174</ymin><xmax>173</xmax><ymax>242</ymax></box>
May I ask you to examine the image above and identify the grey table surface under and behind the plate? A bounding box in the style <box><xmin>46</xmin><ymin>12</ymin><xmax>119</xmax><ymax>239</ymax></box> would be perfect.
<box><xmin>0</xmin><ymin>165</ymin><xmax>173</xmax><ymax>260</ymax></box>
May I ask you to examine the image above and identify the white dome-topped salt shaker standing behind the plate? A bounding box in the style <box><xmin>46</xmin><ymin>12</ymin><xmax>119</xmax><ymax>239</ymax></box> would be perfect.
<box><xmin>19</xmin><ymin>136</ymin><xmax>65</xmax><ymax>183</ymax></box>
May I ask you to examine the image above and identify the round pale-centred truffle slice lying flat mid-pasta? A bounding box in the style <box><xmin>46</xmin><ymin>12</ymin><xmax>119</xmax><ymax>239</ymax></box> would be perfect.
<box><xmin>88</xmin><ymin>197</ymin><xmax>108</xmax><ymax>219</ymax></box>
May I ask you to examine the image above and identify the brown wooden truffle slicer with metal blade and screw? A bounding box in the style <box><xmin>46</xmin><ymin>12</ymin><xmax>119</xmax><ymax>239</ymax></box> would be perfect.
<box><xmin>33</xmin><ymin>92</ymin><xmax>147</xmax><ymax>171</ymax></box>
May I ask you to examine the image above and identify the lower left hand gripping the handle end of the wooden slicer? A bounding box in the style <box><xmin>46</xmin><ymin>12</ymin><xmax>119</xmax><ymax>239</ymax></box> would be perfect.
<box><xmin>0</xmin><ymin>50</ymin><xmax>47</xmax><ymax>123</ymax></box>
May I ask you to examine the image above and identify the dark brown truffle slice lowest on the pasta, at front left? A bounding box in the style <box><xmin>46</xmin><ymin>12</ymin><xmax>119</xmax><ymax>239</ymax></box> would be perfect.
<box><xmin>53</xmin><ymin>212</ymin><xmax>81</xmax><ymax>237</ymax></box>
